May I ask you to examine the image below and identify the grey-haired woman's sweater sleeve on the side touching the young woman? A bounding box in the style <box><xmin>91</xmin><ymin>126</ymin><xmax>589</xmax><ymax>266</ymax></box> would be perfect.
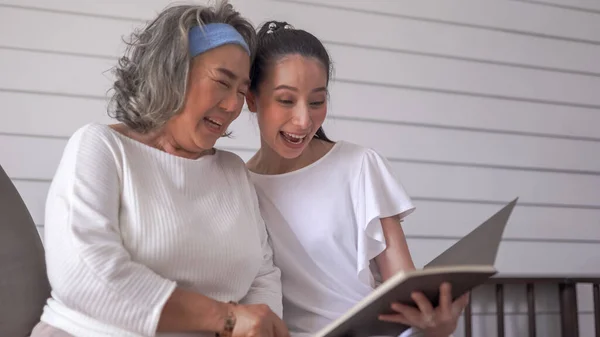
<box><xmin>241</xmin><ymin>171</ymin><xmax>283</xmax><ymax>318</ymax></box>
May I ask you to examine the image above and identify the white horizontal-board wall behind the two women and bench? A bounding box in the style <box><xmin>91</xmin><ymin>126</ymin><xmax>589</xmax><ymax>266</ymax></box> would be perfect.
<box><xmin>0</xmin><ymin>0</ymin><xmax>600</xmax><ymax>336</ymax></box>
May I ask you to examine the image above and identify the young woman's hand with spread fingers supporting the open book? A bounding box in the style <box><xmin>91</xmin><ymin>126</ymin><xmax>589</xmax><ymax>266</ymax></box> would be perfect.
<box><xmin>379</xmin><ymin>283</ymin><xmax>469</xmax><ymax>337</ymax></box>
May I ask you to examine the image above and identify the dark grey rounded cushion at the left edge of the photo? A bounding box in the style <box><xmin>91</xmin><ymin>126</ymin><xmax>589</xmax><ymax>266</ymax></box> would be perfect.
<box><xmin>0</xmin><ymin>166</ymin><xmax>50</xmax><ymax>337</ymax></box>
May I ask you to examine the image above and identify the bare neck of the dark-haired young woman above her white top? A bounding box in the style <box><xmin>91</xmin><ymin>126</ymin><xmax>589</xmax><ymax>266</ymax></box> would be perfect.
<box><xmin>248</xmin><ymin>138</ymin><xmax>333</xmax><ymax>175</ymax></box>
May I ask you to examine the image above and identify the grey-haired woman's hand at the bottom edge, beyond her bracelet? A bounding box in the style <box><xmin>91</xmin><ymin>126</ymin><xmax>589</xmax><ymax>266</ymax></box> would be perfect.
<box><xmin>231</xmin><ymin>304</ymin><xmax>290</xmax><ymax>337</ymax></box>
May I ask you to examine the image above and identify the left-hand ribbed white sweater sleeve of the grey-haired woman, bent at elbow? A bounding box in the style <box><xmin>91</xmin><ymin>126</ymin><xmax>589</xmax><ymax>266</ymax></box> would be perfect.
<box><xmin>45</xmin><ymin>127</ymin><xmax>176</xmax><ymax>336</ymax></box>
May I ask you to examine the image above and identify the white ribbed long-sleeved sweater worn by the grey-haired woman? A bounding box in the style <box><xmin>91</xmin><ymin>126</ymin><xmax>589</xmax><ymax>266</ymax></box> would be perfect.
<box><xmin>42</xmin><ymin>124</ymin><xmax>282</xmax><ymax>337</ymax></box>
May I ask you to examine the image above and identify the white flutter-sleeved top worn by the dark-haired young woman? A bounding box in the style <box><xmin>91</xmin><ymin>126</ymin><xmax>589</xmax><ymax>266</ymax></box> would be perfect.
<box><xmin>250</xmin><ymin>141</ymin><xmax>414</xmax><ymax>333</ymax></box>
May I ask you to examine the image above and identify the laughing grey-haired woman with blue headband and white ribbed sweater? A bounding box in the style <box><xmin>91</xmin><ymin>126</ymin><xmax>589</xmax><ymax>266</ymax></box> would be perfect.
<box><xmin>32</xmin><ymin>3</ymin><xmax>288</xmax><ymax>337</ymax></box>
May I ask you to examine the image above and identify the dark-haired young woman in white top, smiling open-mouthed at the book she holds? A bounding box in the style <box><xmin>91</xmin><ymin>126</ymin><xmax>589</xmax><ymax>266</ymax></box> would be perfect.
<box><xmin>246</xmin><ymin>21</ymin><xmax>468</xmax><ymax>337</ymax></box>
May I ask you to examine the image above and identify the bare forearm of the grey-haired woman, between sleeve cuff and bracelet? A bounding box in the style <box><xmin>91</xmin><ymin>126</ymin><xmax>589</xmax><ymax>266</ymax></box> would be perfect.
<box><xmin>157</xmin><ymin>288</ymin><xmax>229</xmax><ymax>332</ymax></box>
